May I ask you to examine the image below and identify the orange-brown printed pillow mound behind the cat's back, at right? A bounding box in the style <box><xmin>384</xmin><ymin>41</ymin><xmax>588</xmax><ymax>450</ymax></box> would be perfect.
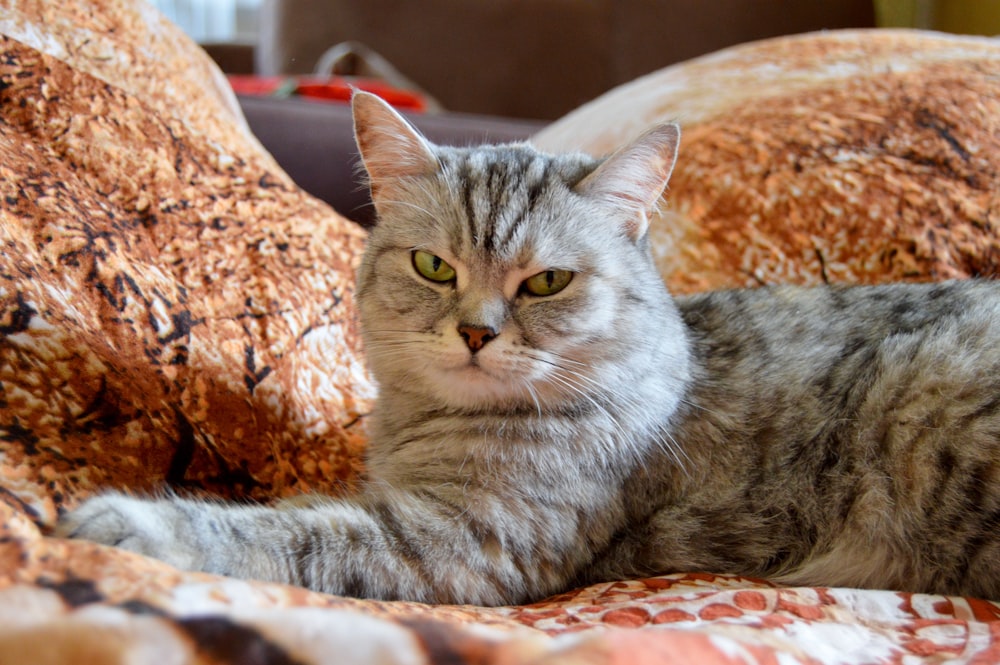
<box><xmin>533</xmin><ymin>30</ymin><xmax>1000</xmax><ymax>292</ymax></box>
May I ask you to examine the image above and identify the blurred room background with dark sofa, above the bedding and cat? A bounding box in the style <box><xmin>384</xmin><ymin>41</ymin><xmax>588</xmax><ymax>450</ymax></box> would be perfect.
<box><xmin>150</xmin><ymin>0</ymin><xmax>1000</xmax><ymax>224</ymax></box>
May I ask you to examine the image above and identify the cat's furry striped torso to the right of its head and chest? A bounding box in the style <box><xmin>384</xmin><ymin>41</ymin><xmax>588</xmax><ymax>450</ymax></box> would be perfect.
<box><xmin>656</xmin><ymin>280</ymin><xmax>1000</xmax><ymax>595</ymax></box>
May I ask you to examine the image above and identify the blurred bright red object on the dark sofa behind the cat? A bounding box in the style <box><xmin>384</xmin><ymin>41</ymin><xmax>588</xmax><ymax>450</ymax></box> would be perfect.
<box><xmin>228</xmin><ymin>75</ymin><xmax>427</xmax><ymax>112</ymax></box>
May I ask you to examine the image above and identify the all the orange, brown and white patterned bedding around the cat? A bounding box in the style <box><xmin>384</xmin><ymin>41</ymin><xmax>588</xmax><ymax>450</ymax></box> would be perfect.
<box><xmin>0</xmin><ymin>0</ymin><xmax>1000</xmax><ymax>665</ymax></box>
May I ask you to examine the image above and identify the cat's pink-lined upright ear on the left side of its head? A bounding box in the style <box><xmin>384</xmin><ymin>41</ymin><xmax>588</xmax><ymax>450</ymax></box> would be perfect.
<box><xmin>351</xmin><ymin>90</ymin><xmax>438</xmax><ymax>192</ymax></box>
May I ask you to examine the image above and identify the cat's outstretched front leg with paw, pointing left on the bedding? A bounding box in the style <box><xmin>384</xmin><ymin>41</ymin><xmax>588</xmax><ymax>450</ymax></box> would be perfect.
<box><xmin>57</xmin><ymin>488</ymin><xmax>589</xmax><ymax>605</ymax></box>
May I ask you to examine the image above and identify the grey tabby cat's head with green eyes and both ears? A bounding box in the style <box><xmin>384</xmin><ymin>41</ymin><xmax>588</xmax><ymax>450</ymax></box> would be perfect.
<box><xmin>353</xmin><ymin>93</ymin><xmax>679</xmax><ymax>409</ymax></box>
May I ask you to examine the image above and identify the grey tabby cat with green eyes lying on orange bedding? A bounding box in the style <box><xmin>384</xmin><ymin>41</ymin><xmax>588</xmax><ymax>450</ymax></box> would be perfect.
<box><xmin>59</xmin><ymin>93</ymin><xmax>1000</xmax><ymax>605</ymax></box>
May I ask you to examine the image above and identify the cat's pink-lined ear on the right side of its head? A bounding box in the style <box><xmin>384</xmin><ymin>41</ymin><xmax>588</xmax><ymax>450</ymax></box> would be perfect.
<box><xmin>576</xmin><ymin>123</ymin><xmax>681</xmax><ymax>240</ymax></box>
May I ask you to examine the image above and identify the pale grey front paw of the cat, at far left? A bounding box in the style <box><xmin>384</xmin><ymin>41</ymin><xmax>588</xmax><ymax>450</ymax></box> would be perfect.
<box><xmin>55</xmin><ymin>493</ymin><xmax>203</xmax><ymax>570</ymax></box>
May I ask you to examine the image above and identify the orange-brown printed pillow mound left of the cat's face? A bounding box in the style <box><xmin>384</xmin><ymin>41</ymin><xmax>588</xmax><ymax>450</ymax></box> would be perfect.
<box><xmin>0</xmin><ymin>0</ymin><xmax>373</xmax><ymax>524</ymax></box>
